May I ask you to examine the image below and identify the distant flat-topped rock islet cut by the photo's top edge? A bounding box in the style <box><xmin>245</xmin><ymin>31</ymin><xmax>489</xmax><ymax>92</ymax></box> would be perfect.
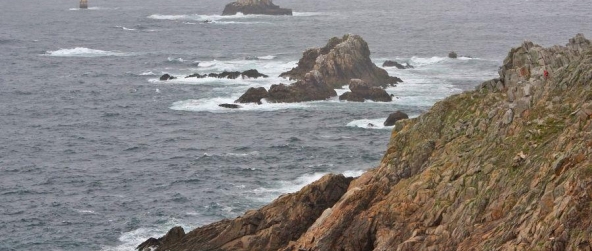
<box><xmin>222</xmin><ymin>0</ymin><xmax>292</xmax><ymax>16</ymax></box>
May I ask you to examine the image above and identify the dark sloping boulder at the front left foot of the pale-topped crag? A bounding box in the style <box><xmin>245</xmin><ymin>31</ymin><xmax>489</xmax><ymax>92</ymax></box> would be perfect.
<box><xmin>267</xmin><ymin>71</ymin><xmax>337</xmax><ymax>103</ymax></box>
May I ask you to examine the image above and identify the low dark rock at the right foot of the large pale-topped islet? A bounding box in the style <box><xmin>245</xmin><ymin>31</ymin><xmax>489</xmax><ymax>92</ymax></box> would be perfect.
<box><xmin>339</xmin><ymin>79</ymin><xmax>393</xmax><ymax>102</ymax></box>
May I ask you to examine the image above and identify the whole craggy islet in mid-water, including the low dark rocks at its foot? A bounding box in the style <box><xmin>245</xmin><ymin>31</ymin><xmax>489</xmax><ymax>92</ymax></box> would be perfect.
<box><xmin>235</xmin><ymin>34</ymin><xmax>402</xmax><ymax>103</ymax></box>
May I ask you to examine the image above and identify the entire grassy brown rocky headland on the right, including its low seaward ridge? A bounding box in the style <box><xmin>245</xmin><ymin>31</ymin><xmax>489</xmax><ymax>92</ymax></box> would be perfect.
<box><xmin>138</xmin><ymin>35</ymin><xmax>592</xmax><ymax>251</ymax></box>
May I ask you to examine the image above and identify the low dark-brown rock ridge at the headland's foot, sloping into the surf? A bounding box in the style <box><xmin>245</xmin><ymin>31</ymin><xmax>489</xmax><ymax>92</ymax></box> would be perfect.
<box><xmin>138</xmin><ymin>174</ymin><xmax>352</xmax><ymax>251</ymax></box>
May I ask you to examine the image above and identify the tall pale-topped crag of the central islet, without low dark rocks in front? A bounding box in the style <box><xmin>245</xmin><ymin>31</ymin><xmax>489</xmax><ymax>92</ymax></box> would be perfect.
<box><xmin>280</xmin><ymin>34</ymin><xmax>402</xmax><ymax>88</ymax></box>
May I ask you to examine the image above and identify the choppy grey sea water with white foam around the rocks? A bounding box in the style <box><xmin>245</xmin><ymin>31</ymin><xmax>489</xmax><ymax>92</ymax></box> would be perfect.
<box><xmin>0</xmin><ymin>0</ymin><xmax>592</xmax><ymax>251</ymax></box>
